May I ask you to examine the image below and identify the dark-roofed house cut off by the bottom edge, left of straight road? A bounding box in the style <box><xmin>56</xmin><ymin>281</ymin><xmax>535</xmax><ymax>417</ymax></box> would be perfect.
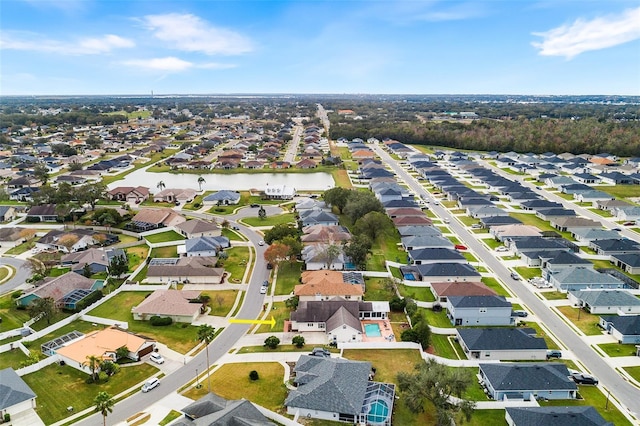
<box><xmin>505</xmin><ymin>405</ymin><xmax>614</xmax><ymax>426</ymax></box>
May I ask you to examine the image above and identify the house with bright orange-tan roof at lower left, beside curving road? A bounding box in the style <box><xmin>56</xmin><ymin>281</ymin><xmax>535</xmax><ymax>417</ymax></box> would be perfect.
<box><xmin>55</xmin><ymin>327</ymin><xmax>156</xmax><ymax>374</ymax></box>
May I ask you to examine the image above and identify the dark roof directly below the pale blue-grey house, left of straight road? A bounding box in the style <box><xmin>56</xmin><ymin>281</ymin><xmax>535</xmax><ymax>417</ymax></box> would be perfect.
<box><xmin>458</xmin><ymin>327</ymin><xmax>547</xmax><ymax>351</ymax></box>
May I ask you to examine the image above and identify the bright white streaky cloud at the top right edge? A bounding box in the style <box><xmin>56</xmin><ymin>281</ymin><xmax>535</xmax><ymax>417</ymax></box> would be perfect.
<box><xmin>531</xmin><ymin>7</ymin><xmax>640</xmax><ymax>59</ymax></box>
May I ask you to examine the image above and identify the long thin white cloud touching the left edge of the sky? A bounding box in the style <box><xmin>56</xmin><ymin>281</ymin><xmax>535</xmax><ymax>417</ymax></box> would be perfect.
<box><xmin>0</xmin><ymin>32</ymin><xmax>135</xmax><ymax>55</ymax></box>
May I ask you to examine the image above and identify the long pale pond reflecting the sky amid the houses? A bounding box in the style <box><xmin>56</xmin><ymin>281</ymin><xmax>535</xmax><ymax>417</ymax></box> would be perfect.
<box><xmin>108</xmin><ymin>167</ymin><xmax>335</xmax><ymax>192</ymax></box>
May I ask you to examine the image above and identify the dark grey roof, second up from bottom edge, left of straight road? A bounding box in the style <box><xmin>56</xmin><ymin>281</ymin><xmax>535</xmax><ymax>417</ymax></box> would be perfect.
<box><xmin>480</xmin><ymin>362</ymin><xmax>577</xmax><ymax>391</ymax></box>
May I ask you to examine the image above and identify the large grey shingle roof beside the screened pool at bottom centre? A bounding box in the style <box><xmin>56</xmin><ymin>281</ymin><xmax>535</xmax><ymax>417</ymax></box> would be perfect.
<box><xmin>284</xmin><ymin>355</ymin><xmax>371</xmax><ymax>415</ymax></box>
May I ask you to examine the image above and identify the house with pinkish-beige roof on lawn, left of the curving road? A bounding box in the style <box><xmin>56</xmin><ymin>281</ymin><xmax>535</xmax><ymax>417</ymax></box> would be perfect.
<box><xmin>131</xmin><ymin>290</ymin><xmax>203</xmax><ymax>324</ymax></box>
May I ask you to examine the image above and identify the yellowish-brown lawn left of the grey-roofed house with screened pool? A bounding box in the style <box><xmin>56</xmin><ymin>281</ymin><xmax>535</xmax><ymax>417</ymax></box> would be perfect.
<box><xmin>184</xmin><ymin>362</ymin><xmax>287</xmax><ymax>413</ymax></box>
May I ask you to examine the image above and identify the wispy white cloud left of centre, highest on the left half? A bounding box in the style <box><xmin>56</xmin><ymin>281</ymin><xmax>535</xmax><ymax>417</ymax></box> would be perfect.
<box><xmin>142</xmin><ymin>13</ymin><xmax>252</xmax><ymax>55</ymax></box>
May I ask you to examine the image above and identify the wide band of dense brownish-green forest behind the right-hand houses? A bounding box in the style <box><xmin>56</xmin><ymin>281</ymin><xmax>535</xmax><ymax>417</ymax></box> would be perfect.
<box><xmin>331</xmin><ymin>115</ymin><xmax>640</xmax><ymax>157</ymax></box>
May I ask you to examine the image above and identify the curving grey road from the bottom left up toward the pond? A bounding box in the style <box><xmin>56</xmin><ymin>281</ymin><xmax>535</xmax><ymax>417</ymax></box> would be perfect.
<box><xmin>76</xmin><ymin>209</ymin><xmax>269</xmax><ymax>426</ymax></box>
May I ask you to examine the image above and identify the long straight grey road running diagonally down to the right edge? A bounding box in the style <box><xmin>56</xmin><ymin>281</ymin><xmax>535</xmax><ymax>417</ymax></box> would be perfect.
<box><xmin>373</xmin><ymin>145</ymin><xmax>640</xmax><ymax>422</ymax></box>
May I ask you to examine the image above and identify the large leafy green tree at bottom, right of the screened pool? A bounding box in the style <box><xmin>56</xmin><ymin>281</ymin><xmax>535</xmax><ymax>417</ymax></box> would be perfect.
<box><xmin>396</xmin><ymin>359</ymin><xmax>475</xmax><ymax>426</ymax></box>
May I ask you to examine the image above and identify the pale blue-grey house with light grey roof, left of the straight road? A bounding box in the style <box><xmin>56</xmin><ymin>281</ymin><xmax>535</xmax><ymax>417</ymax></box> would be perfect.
<box><xmin>445</xmin><ymin>296</ymin><xmax>515</xmax><ymax>327</ymax></box>
